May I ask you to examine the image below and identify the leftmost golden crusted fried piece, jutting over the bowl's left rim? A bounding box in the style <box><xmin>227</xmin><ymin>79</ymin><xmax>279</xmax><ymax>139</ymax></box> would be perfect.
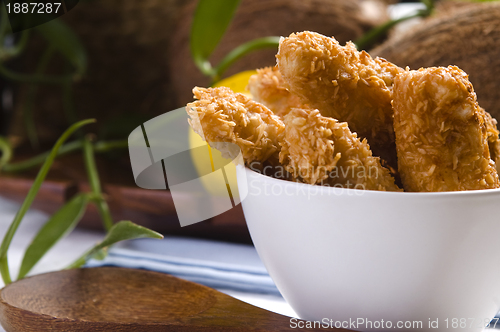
<box><xmin>186</xmin><ymin>87</ymin><xmax>285</xmax><ymax>164</ymax></box>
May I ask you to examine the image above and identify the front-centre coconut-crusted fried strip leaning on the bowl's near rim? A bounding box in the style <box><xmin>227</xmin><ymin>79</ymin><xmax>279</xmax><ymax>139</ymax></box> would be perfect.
<box><xmin>280</xmin><ymin>108</ymin><xmax>401</xmax><ymax>191</ymax></box>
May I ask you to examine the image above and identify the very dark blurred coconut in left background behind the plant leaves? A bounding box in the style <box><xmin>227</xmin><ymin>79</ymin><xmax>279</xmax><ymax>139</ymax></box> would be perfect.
<box><xmin>10</xmin><ymin>0</ymin><xmax>186</xmax><ymax>142</ymax></box>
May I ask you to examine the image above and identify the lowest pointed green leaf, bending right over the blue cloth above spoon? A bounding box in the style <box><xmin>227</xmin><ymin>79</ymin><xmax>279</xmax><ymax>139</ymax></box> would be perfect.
<box><xmin>67</xmin><ymin>221</ymin><xmax>163</xmax><ymax>269</ymax></box>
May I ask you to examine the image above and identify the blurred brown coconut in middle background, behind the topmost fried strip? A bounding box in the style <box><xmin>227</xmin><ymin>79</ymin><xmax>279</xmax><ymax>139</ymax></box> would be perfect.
<box><xmin>170</xmin><ymin>0</ymin><xmax>387</xmax><ymax>106</ymax></box>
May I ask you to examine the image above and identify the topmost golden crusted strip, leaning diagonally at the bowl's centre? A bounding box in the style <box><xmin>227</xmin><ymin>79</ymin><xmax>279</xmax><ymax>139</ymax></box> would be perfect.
<box><xmin>276</xmin><ymin>31</ymin><xmax>403</xmax><ymax>166</ymax></box>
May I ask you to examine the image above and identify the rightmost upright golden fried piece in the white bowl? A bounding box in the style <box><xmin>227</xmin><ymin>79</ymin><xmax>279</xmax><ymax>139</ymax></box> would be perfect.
<box><xmin>393</xmin><ymin>66</ymin><xmax>500</xmax><ymax>191</ymax></box>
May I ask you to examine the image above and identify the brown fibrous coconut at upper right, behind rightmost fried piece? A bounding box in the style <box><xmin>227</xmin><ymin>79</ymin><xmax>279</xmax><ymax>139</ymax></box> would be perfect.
<box><xmin>370</xmin><ymin>3</ymin><xmax>500</xmax><ymax>119</ymax></box>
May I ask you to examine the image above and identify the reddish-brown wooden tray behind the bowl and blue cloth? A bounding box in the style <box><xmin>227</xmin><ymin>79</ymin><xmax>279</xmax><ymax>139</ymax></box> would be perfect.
<box><xmin>0</xmin><ymin>153</ymin><xmax>251</xmax><ymax>243</ymax></box>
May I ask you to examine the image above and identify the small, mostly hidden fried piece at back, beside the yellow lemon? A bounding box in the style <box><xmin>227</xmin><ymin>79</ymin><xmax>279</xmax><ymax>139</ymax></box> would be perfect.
<box><xmin>247</xmin><ymin>67</ymin><xmax>304</xmax><ymax>118</ymax></box>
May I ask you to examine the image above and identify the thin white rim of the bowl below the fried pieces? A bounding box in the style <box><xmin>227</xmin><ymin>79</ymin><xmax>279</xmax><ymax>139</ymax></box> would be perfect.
<box><xmin>242</xmin><ymin>165</ymin><xmax>500</xmax><ymax>197</ymax></box>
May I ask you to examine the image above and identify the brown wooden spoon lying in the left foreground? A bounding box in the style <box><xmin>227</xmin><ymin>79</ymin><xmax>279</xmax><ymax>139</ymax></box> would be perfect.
<box><xmin>0</xmin><ymin>267</ymin><xmax>347</xmax><ymax>332</ymax></box>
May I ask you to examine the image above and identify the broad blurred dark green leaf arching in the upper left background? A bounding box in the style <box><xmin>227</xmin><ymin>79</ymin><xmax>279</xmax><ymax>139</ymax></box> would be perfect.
<box><xmin>35</xmin><ymin>19</ymin><xmax>87</xmax><ymax>77</ymax></box>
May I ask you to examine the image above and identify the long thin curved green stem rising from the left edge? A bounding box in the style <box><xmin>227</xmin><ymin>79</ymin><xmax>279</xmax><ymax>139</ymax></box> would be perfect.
<box><xmin>0</xmin><ymin>119</ymin><xmax>95</xmax><ymax>284</ymax></box>
